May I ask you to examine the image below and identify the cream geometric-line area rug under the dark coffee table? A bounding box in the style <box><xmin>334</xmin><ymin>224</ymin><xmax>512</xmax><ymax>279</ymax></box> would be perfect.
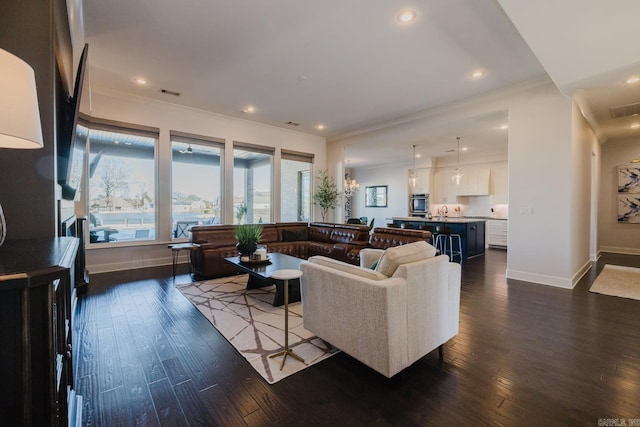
<box><xmin>177</xmin><ymin>275</ymin><xmax>340</xmax><ymax>384</ymax></box>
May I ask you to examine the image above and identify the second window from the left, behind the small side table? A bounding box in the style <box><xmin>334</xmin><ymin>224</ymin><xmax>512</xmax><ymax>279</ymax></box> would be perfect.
<box><xmin>171</xmin><ymin>131</ymin><xmax>224</xmax><ymax>239</ymax></box>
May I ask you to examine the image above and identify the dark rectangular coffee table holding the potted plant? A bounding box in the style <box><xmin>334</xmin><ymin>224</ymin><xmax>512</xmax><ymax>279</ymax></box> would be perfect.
<box><xmin>225</xmin><ymin>252</ymin><xmax>304</xmax><ymax>307</ymax></box>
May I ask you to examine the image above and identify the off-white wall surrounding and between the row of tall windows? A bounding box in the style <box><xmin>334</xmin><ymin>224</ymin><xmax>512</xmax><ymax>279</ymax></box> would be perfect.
<box><xmin>84</xmin><ymin>88</ymin><xmax>327</xmax><ymax>273</ymax></box>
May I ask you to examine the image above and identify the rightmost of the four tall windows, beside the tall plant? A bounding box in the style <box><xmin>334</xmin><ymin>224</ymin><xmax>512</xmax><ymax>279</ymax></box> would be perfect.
<box><xmin>280</xmin><ymin>150</ymin><xmax>313</xmax><ymax>221</ymax></box>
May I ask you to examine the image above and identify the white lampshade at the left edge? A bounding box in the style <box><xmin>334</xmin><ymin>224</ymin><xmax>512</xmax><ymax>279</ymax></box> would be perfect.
<box><xmin>0</xmin><ymin>49</ymin><xmax>44</xmax><ymax>148</ymax></box>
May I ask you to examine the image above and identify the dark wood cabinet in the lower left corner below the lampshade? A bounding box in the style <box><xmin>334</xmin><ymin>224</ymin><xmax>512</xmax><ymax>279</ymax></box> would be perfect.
<box><xmin>0</xmin><ymin>237</ymin><xmax>81</xmax><ymax>426</ymax></box>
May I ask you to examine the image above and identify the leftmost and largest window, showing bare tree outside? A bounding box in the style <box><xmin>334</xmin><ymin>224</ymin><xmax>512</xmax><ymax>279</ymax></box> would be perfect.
<box><xmin>88</xmin><ymin>122</ymin><xmax>158</xmax><ymax>243</ymax></box>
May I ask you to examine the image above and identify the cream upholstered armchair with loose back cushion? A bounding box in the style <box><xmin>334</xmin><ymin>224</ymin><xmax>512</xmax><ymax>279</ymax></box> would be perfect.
<box><xmin>301</xmin><ymin>242</ymin><xmax>460</xmax><ymax>378</ymax></box>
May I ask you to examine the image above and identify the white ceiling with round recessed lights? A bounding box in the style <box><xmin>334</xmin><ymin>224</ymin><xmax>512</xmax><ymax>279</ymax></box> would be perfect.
<box><xmin>83</xmin><ymin>0</ymin><xmax>640</xmax><ymax>166</ymax></box>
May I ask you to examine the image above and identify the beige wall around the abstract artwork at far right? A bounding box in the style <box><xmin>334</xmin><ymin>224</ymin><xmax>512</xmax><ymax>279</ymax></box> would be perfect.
<box><xmin>598</xmin><ymin>137</ymin><xmax>640</xmax><ymax>255</ymax></box>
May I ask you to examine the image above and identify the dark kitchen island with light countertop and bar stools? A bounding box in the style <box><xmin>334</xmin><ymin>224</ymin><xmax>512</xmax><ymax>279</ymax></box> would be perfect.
<box><xmin>392</xmin><ymin>216</ymin><xmax>486</xmax><ymax>259</ymax></box>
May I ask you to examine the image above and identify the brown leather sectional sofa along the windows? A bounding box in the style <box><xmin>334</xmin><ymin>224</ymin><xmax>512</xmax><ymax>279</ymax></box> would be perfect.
<box><xmin>191</xmin><ymin>222</ymin><xmax>431</xmax><ymax>279</ymax></box>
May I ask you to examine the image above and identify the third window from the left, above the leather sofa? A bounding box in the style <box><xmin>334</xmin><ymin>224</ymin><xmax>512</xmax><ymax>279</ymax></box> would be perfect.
<box><xmin>233</xmin><ymin>142</ymin><xmax>275</xmax><ymax>224</ymax></box>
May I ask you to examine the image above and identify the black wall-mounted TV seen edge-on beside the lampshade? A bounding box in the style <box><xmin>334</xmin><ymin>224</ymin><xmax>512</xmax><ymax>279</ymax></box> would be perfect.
<box><xmin>58</xmin><ymin>44</ymin><xmax>89</xmax><ymax>200</ymax></box>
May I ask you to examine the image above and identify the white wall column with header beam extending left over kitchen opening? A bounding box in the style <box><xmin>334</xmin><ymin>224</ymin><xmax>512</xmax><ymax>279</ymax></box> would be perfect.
<box><xmin>327</xmin><ymin>82</ymin><xmax>588</xmax><ymax>288</ymax></box>
